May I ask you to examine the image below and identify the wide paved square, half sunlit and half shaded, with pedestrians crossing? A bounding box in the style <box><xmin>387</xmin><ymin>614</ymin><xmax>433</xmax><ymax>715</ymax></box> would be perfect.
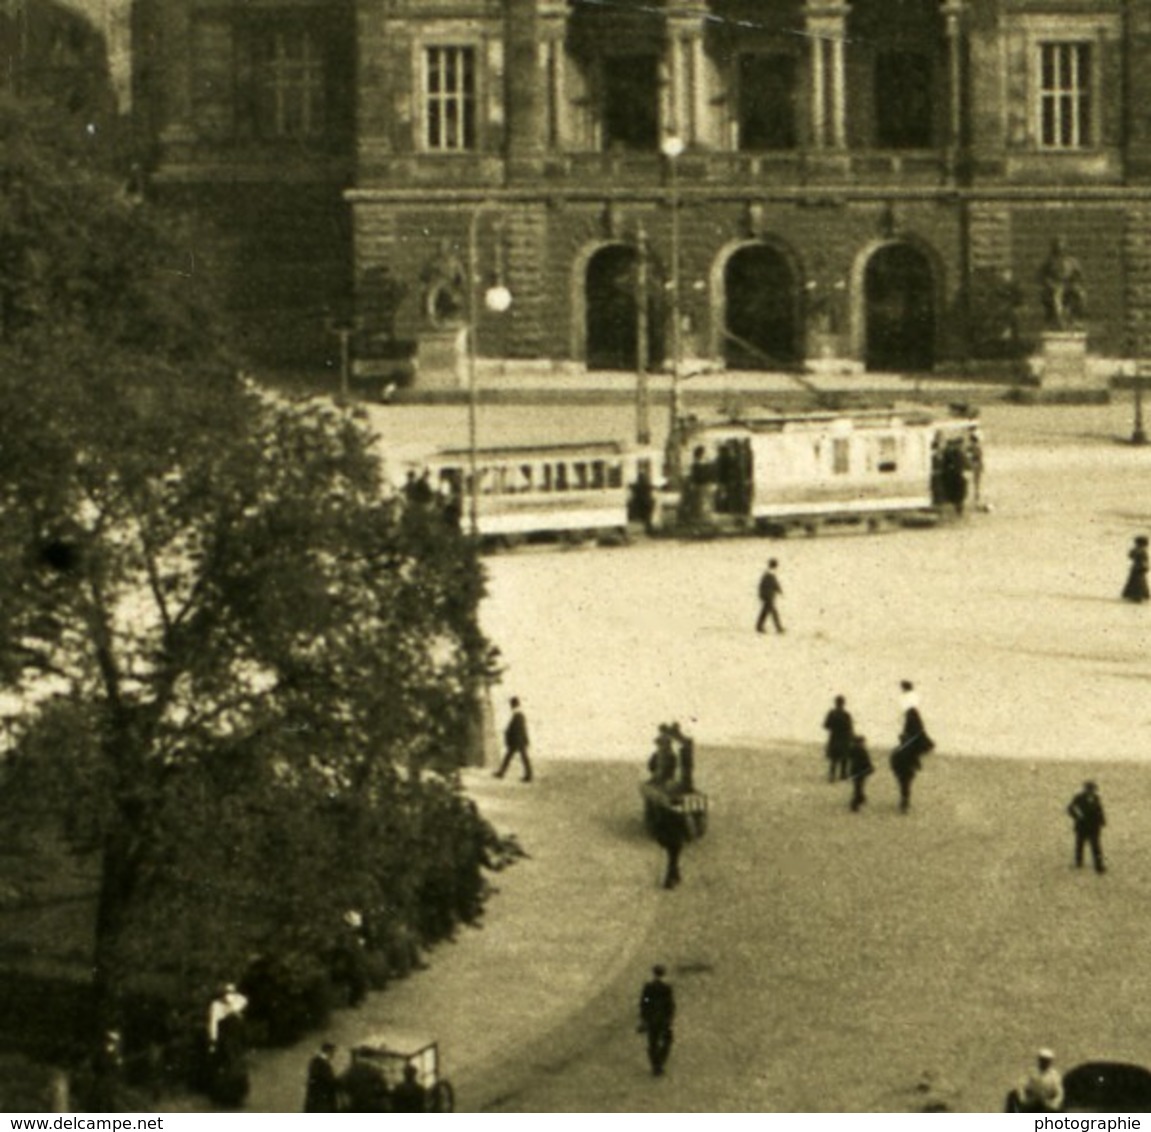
<box><xmin>233</xmin><ymin>407</ymin><xmax>1151</xmax><ymax>1111</ymax></box>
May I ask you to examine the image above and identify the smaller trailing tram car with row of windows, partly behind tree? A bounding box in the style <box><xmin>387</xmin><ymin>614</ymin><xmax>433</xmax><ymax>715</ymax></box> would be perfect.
<box><xmin>410</xmin><ymin>441</ymin><xmax>662</xmax><ymax>547</ymax></box>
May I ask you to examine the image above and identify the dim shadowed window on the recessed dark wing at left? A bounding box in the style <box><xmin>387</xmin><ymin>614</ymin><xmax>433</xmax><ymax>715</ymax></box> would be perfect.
<box><xmin>258</xmin><ymin>29</ymin><xmax>325</xmax><ymax>138</ymax></box>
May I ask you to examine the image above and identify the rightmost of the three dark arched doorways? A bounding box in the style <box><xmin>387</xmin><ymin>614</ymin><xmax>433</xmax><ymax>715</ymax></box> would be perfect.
<box><xmin>863</xmin><ymin>243</ymin><xmax>936</xmax><ymax>372</ymax></box>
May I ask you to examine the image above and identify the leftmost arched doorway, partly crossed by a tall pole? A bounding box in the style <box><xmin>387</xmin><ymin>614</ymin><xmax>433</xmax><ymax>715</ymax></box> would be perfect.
<box><xmin>584</xmin><ymin>244</ymin><xmax>663</xmax><ymax>370</ymax></box>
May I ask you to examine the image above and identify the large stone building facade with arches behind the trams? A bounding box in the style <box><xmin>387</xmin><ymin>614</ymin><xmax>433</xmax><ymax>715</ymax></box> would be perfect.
<box><xmin>135</xmin><ymin>0</ymin><xmax>1151</xmax><ymax>371</ymax></box>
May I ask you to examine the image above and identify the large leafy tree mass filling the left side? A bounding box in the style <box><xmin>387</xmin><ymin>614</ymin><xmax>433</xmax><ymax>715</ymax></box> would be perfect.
<box><xmin>0</xmin><ymin>92</ymin><xmax>498</xmax><ymax>1050</ymax></box>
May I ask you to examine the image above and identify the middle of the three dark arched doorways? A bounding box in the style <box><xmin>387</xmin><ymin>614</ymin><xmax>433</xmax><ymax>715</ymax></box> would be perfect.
<box><xmin>722</xmin><ymin>244</ymin><xmax>802</xmax><ymax>370</ymax></box>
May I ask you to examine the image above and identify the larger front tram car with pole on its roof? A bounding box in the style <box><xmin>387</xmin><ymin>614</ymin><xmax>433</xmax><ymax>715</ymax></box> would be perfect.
<box><xmin>662</xmin><ymin>409</ymin><xmax>982</xmax><ymax>533</ymax></box>
